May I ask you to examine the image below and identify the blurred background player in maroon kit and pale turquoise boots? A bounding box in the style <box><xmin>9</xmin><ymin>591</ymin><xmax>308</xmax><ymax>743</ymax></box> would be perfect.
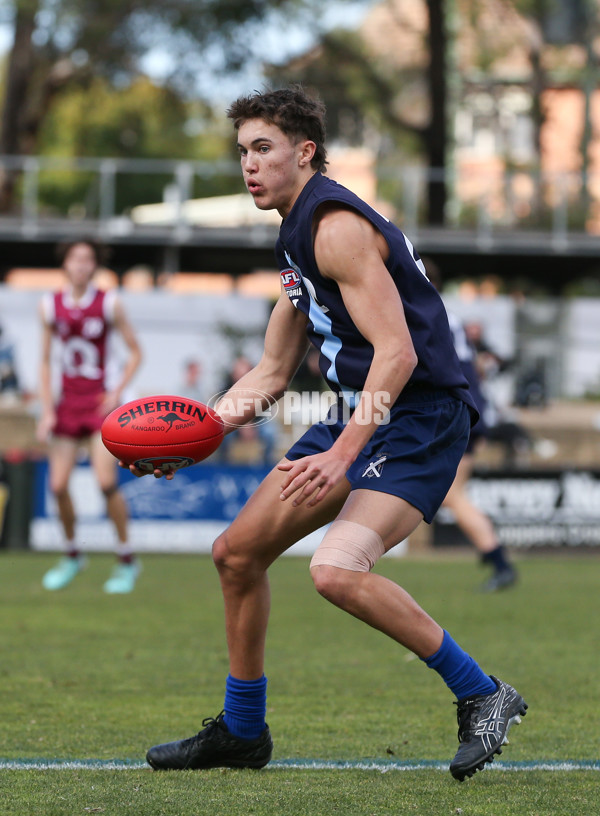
<box><xmin>37</xmin><ymin>240</ymin><xmax>141</xmax><ymax>593</ymax></box>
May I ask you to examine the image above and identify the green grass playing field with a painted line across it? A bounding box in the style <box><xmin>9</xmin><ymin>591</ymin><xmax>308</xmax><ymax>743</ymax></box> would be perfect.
<box><xmin>0</xmin><ymin>552</ymin><xmax>600</xmax><ymax>816</ymax></box>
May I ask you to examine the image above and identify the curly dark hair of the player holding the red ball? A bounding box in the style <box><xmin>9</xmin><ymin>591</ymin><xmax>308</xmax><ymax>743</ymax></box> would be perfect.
<box><xmin>227</xmin><ymin>85</ymin><xmax>327</xmax><ymax>173</ymax></box>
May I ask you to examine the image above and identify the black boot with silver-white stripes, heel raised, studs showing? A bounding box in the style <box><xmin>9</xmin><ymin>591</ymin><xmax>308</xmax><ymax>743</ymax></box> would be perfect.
<box><xmin>450</xmin><ymin>675</ymin><xmax>527</xmax><ymax>782</ymax></box>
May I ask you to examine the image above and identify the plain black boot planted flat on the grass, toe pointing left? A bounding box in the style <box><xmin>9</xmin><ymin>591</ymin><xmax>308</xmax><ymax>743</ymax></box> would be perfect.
<box><xmin>146</xmin><ymin>712</ymin><xmax>273</xmax><ymax>771</ymax></box>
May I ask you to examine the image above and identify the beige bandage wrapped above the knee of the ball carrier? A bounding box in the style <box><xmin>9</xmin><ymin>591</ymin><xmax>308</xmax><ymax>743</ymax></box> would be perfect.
<box><xmin>310</xmin><ymin>519</ymin><xmax>385</xmax><ymax>572</ymax></box>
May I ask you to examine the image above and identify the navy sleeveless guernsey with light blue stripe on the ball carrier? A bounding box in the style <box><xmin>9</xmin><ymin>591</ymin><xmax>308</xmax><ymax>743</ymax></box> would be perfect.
<box><xmin>275</xmin><ymin>173</ymin><xmax>477</xmax><ymax>421</ymax></box>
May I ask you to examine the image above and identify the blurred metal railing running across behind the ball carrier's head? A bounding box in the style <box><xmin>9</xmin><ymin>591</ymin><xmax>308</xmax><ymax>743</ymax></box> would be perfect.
<box><xmin>0</xmin><ymin>156</ymin><xmax>600</xmax><ymax>252</ymax></box>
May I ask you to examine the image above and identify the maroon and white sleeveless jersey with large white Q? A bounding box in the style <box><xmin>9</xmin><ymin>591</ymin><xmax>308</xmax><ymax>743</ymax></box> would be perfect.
<box><xmin>42</xmin><ymin>286</ymin><xmax>115</xmax><ymax>399</ymax></box>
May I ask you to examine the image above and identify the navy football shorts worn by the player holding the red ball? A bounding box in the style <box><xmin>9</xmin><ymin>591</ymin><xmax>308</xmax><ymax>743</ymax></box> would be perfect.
<box><xmin>286</xmin><ymin>388</ymin><xmax>471</xmax><ymax>523</ymax></box>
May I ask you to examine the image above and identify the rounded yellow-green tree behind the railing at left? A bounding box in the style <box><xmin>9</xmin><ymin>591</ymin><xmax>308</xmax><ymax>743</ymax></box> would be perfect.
<box><xmin>30</xmin><ymin>76</ymin><xmax>237</xmax><ymax>217</ymax></box>
